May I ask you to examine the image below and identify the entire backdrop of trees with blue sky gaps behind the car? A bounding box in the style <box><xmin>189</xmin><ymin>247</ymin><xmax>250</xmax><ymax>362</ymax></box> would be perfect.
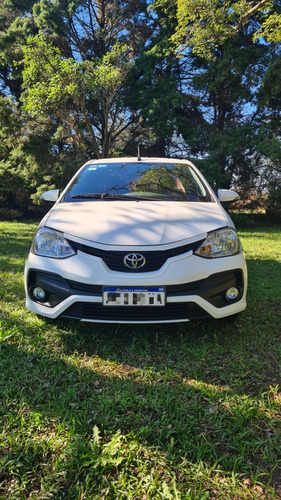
<box><xmin>0</xmin><ymin>0</ymin><xmax>281</xmax><ymax>215</ymax></box>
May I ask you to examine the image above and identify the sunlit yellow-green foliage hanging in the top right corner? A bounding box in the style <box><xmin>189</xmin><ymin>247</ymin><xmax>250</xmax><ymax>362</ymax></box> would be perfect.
<box><xmin>155</xmin><ymin>0</ymin><xmax>281</xmax><ymax>58</ymax></box>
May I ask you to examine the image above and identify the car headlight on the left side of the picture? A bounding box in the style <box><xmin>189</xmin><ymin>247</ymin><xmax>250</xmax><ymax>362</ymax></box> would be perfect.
<box><xmin>31</xmin><ymin>228</ymin><xmax>76</xmax><ymax>259</ymax></box>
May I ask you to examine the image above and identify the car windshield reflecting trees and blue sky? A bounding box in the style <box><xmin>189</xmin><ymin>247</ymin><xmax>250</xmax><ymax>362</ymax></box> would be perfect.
<box><xmin>63</xmin><ymin>162</ymin><xmax>212</xmax><ymax>202</ymax></box>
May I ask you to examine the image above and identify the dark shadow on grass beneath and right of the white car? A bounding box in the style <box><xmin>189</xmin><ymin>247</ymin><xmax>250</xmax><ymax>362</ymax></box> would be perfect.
<box><xmin>48</xmin><ymin>260</ymin><xmax>281</xmax><ymax>397</ymax></box>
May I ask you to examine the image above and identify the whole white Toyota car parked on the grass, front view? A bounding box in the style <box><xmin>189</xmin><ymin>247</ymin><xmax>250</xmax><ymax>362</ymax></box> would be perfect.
<box><xmin>25</xmin><ymin>158</ymin><xmax>247</xmax><ymax>323</ymax></box>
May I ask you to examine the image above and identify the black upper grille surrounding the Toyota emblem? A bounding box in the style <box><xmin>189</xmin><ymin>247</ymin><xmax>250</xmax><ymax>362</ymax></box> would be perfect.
<box><xmin>68</xmin><ymin>240</ymin><xmax>204</xmax><ymax>273</ymax></box>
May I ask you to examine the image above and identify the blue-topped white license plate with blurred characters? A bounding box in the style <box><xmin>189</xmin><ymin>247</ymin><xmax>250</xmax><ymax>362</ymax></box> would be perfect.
<box><xmin>103</xmin><ymin>286</ymin><xmax>165</xmax><ymax>306</ymax></box>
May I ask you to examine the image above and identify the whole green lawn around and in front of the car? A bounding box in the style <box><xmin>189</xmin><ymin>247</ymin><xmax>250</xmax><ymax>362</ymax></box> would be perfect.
<box><xmin>0</xmin><ymin>222</ymin><xmax>281</xmax><ymax>500</ymax></box>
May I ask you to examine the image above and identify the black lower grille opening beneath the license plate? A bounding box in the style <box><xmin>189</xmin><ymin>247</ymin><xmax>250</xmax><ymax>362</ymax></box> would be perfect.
<box><xmin>62</xmin><ymin>302</ymin><xmax>210</xmax><ymax>323</ymax></box>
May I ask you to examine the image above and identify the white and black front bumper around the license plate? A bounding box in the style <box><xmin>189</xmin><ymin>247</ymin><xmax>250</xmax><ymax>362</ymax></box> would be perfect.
<box><xmin>25</xmin><ymin>251</ymin><xmax>247</xmax><ymax>323</ymax></box>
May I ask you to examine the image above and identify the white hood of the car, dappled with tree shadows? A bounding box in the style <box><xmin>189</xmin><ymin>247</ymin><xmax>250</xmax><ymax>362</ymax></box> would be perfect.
<box><xmin>44</xmin><ymin>200</ymin><xmax>232</xmax><ymax>246</ymax></box>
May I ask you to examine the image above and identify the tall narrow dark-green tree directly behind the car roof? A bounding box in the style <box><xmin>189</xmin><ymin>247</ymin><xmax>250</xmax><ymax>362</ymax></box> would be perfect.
<box><xmin>126</xmin><ymin>3</ymin><xmax>188</xmax><ymax>157</ymax></box>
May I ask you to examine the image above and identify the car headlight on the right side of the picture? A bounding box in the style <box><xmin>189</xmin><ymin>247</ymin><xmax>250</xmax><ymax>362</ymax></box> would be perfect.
<box><xmin>195</xmin><ymin>228</ymin><xmax>241</xmax><ymax>259</ymax></box>
